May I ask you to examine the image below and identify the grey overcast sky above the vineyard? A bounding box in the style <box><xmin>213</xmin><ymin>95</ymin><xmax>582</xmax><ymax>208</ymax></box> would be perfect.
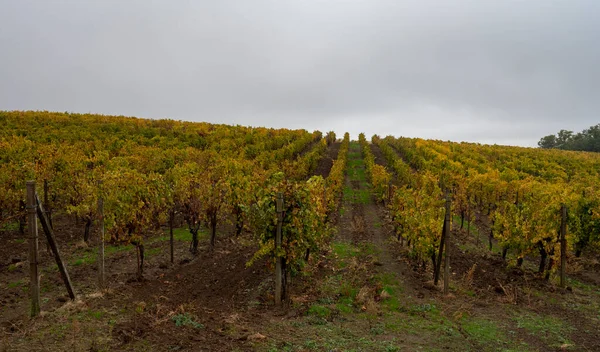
<box><xmin>0</xmin><ymin>0</ymin><xmax>600</xmax><ymax>146</ymax></box>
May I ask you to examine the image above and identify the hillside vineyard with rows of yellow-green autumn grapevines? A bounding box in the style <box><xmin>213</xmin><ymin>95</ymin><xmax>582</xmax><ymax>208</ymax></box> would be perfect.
<box><xmin>0</xmin><ymin>111</ymin><xmax>600</xmax><ymax>351</ymax></box>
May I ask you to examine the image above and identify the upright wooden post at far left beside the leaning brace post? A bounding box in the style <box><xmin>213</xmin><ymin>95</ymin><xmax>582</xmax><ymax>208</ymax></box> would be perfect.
<box><xmin>27</xmin><ymin>181</ymin><xmax>41</xmax><ymax>317</ymax></box>
